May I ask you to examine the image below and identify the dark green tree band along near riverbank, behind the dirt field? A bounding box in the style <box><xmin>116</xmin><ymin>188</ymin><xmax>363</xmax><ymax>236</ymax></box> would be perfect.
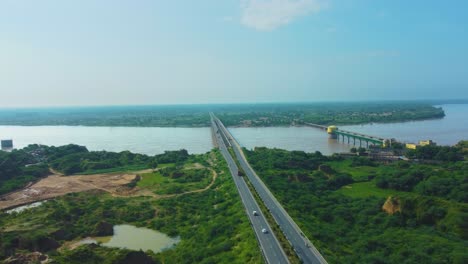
<box><xmin>0</xmin><ymin>144</ymin><xmax>189</xmax><ymax>194</ymax></box>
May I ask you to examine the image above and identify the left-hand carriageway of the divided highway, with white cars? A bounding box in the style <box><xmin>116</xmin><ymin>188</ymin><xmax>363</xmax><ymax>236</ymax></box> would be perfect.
<box><xmin>212</xmin><ymin>115</ymin><xmax>289</xmax><ymax>264</ymax></box>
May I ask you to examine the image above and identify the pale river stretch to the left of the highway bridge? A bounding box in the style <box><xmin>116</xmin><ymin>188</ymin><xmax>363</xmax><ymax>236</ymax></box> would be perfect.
<box><xmin>0</xmin><ymin>126</ymin><xmax>213</xmax><ymax>155</ymax></box>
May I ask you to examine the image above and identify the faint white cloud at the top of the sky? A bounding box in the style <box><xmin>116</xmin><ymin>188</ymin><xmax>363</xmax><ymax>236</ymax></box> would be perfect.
<box><xmin>241</xmin><ymin>0</ymin><xmax>326</xmax><ymax>31</ymax></box>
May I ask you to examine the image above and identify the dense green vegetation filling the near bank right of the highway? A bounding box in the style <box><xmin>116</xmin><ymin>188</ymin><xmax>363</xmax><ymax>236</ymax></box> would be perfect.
<box><xmin>245</xmin><ymin>148</ymin><xmax>468</xmax><ymax>263</ymax></box>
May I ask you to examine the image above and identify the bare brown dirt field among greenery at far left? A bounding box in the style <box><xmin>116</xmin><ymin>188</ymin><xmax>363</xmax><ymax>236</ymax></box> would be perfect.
<box><xmin>0</xmin><ymin>174</ymin><xmax>137</xmax><ymax>210</ymax></box>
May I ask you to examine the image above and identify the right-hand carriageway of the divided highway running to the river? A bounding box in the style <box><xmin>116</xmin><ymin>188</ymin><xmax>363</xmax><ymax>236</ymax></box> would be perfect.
<box><xmin>212</xmin><ymin>115</ymin><xmax>327</xmax><ymax>264</ymax></box>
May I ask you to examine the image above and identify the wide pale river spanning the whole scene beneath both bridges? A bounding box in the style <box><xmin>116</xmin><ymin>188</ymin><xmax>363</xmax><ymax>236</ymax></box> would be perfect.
<box><xmin>0</xmin><ymin>104</ymin><xmax>468</xmax><ymax>155</ymax></box>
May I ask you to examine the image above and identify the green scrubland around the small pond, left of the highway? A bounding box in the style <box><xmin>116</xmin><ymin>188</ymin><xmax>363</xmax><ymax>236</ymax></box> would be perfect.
<box><xmin>0</xmin><ymin>152</ymin><xmax>262</xmax><ymax>263</ymax></box>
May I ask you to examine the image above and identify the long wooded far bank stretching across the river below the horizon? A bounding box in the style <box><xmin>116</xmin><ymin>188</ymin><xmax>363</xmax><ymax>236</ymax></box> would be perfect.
<box><xmin>0</xmin><ymin>102</ymin><xmax>444</xmax><ymax>127</ymax></box>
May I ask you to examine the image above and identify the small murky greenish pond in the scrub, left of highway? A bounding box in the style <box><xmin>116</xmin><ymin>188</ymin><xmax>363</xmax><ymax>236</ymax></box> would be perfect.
<box><xmin>80</xmin><ymin>225</ymin><xmax>180</xmax><ymax>253</ymax></box>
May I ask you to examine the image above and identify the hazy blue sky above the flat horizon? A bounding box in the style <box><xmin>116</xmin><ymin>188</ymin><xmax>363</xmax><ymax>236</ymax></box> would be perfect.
<box><xmin>0</xmin><ymin>0</ymin><xmax>468</xmax><ymax>108</ymax></box>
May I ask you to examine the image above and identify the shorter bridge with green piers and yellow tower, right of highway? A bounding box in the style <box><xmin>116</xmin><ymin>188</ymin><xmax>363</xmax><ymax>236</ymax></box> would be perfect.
<box><xmin>305</xmin><ymin>123</ymin><xmax>391</xmax><ymax>148</ymax></box>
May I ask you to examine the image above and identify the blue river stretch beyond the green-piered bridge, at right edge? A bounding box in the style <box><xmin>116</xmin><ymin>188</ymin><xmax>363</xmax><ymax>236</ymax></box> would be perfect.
<box><xmin>340</xmin><ymin>104</ymin><xmax>468</xmax><ymax>145</ymax></box>
